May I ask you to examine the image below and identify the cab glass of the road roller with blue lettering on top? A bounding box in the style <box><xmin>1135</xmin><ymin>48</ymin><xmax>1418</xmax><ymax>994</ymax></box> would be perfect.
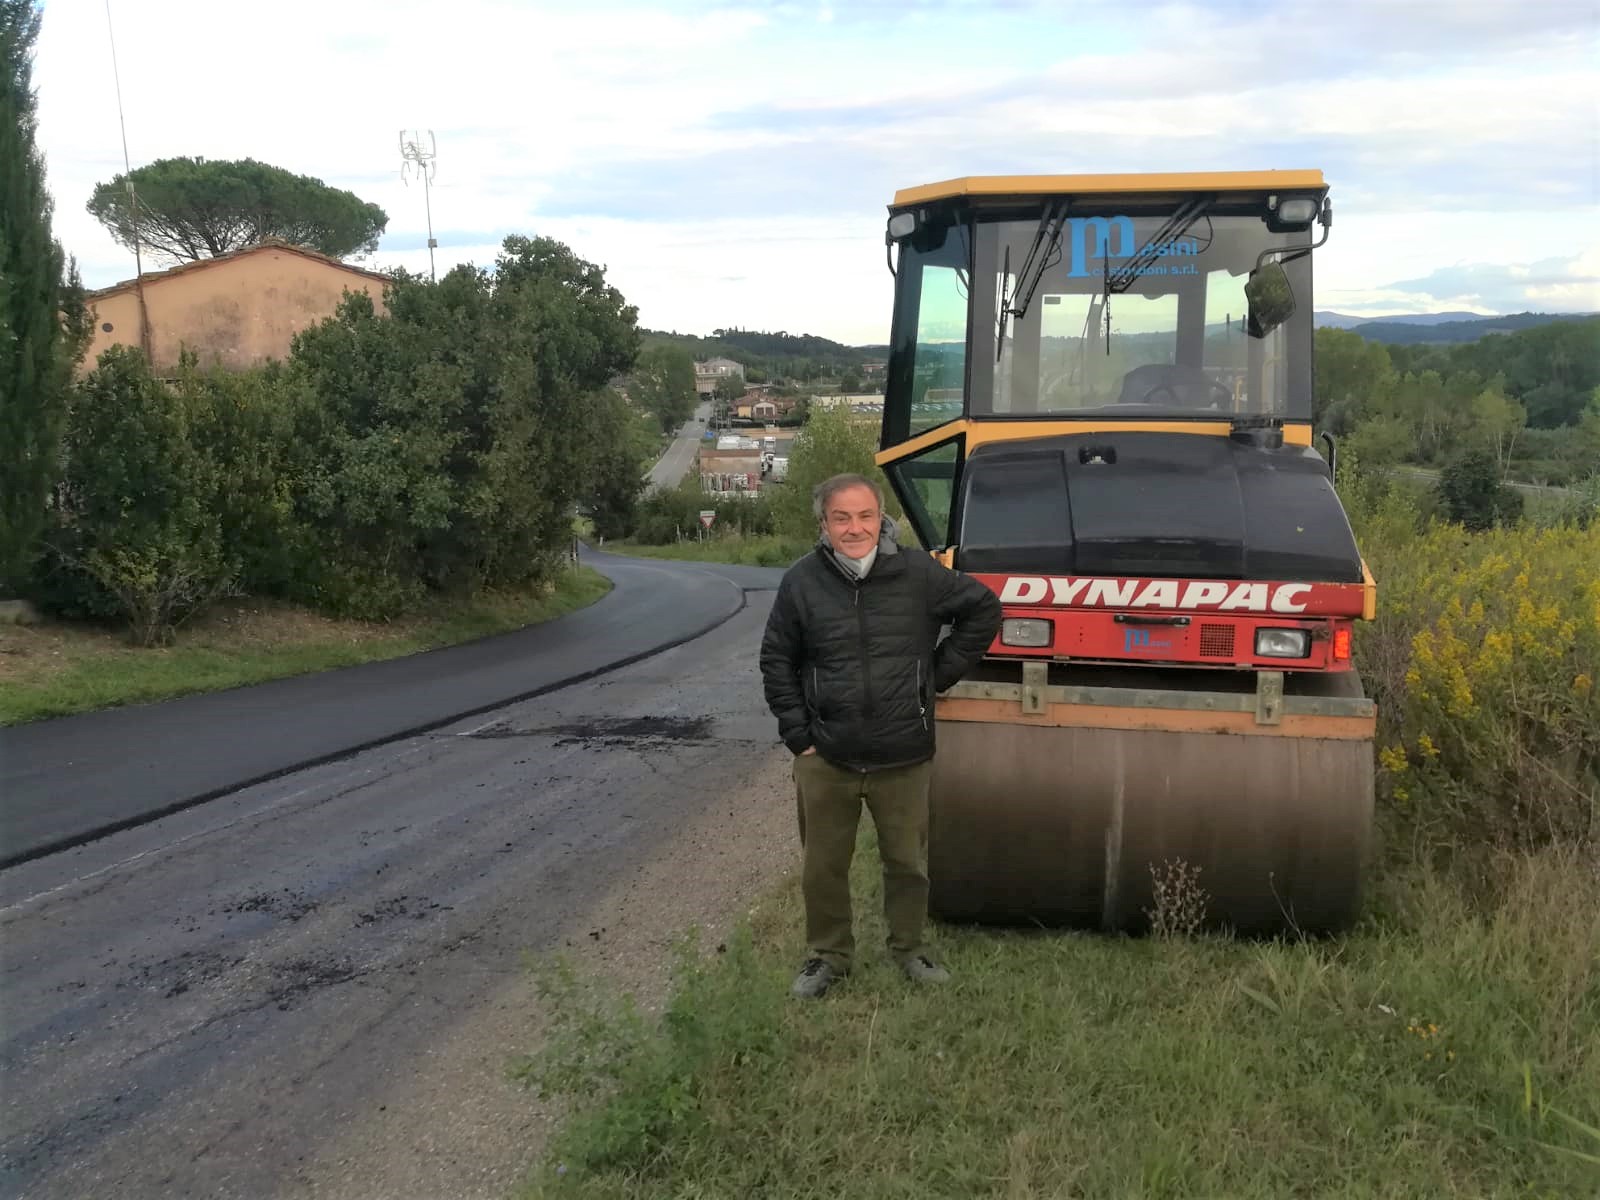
<box><xmin>886</xmin><ymin>203</ymin><xmax>1312</xmax><ymax>440</ymax></box>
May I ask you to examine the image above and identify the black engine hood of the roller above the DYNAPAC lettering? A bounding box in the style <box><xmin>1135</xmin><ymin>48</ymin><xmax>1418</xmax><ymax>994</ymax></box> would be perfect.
<box><xmin>955</xmin><ymin>430</ymin><xmax>1362</xmax><ymax>582</ymax></box>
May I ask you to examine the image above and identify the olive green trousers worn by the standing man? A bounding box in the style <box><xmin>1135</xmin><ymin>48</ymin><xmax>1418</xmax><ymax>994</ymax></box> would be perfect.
<box><xmin>794</xmin><ymin>754</ymin><xmax>933</xmax><ymax>973</ymax></box>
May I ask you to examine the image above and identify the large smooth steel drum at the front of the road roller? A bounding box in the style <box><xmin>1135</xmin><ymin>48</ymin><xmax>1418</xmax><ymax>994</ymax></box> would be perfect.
<box><xmin>930</xmin><ymin>704</ymin><xmax>1374</xmax><ymax>933</ymax></box>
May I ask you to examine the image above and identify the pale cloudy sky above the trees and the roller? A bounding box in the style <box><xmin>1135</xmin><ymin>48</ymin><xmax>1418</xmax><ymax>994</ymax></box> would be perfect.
<box><xmin>34</xmin><ymin>0</ymin><xmax>1600</xmax><ymax>344</ymax></box>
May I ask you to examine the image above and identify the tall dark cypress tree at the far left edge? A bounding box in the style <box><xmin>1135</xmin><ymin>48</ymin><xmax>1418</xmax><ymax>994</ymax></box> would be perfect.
<box><xmin>0</xmin><ymin>0</ymin><xmax>86</xmax><ymax>597</ymax></box>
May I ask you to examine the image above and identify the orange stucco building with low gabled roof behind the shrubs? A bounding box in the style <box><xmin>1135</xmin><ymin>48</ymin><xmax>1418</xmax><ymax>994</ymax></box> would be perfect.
<box><xmin>82</xmin><ymin>242</ymin><xmax>389</xmax><ymax>371</ymax></box>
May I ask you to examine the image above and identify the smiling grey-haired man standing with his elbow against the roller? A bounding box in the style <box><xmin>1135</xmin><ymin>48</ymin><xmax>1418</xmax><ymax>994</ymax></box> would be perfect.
<box><xmin>762</xmin><ymin>475</ymin><xmax>1000</xmax><ymax>997</ymax></box>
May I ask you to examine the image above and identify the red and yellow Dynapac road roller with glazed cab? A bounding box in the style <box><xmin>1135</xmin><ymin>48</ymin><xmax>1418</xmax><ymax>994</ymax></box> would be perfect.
<box><xmin>877</xmin><ymin>170</ymin><xmax>1376</xmax><ymax>936</ymax></box>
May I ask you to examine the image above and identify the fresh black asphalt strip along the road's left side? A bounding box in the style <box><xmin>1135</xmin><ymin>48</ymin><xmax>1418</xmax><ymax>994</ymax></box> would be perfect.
<box><xmin>0</xmin><ymin>552</ymin><xmax>782</xmax><ymax>867</ymax></box>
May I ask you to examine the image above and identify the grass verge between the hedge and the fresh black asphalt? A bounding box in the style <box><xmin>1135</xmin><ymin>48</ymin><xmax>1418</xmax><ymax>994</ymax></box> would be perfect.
<box><xmin>0</xmin><ymin>568</ymin><xmax>611</xmax><ymax>725</ymax></box>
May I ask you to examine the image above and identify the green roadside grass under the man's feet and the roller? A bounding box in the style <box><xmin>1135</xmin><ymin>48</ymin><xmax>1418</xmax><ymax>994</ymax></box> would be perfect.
<box><xmin>523</xmin><ymin>832</ymin><xmax>1600</xmax><ymax>1200</ymax></box>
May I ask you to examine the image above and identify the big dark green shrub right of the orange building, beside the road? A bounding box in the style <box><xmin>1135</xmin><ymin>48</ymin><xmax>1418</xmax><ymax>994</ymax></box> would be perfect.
<box><xmin>291</xmin><ymin>237</ymin><xmax>637</xmax><ymax>618</ymax></box>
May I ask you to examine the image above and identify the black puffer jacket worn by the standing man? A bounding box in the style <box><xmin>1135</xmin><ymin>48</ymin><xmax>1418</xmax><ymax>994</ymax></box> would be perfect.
<box><xmin>762</xmin><ymin>528</ymin><xmax>1000</xmax><ymax>771</ymax></box>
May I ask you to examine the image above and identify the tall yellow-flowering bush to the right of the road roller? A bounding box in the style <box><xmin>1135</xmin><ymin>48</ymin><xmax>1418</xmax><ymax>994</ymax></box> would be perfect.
<box><xmin>1350</xmin><ymin>473</ymin><xmax>1600</xmax><ymax>846</ymax></box>
